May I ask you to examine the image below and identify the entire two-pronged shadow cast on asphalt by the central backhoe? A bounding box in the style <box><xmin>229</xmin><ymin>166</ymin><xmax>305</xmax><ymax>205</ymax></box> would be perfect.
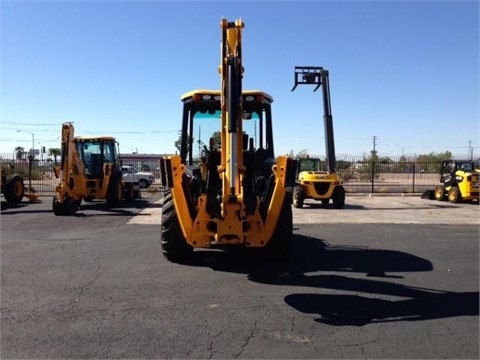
<box><xmin>188</xmin><ymin>235</ymin><xmax>479</xmax><ymax>326</ymax></box>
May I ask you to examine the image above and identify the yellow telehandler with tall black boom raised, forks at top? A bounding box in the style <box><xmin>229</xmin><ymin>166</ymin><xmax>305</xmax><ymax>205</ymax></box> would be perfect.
<box><xmin>292</xmin><ymin>66</ymin><xmax>345</xmax><ymax>209</ymax></box>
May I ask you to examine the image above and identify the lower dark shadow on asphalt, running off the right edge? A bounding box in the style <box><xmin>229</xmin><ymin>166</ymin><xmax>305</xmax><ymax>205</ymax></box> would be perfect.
<box><xmin>285</xmin><ymin>290</ymin><xmax>479</xmax><ymax>326</ymax></box>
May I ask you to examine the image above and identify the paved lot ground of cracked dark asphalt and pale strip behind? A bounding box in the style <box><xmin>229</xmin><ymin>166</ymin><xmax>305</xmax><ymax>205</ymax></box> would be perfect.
<box><xmin>0</xmin><ymin>196</ymin><xmax>480</xmax><ymax>359</ymax></box>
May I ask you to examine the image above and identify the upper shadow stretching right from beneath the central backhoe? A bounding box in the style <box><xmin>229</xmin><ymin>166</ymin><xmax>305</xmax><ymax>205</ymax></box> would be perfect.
<box><xmin>188</xmin><ymin>234</ymin><xmax>433</xmax><ymax>285</ymax></box>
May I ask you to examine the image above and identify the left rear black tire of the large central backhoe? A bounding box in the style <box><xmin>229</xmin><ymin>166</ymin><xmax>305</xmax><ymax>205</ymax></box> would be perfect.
<box><xmin>162</xmin><ymin>190</ymin><xmax>193</xmax><ymax>262</ymax></box>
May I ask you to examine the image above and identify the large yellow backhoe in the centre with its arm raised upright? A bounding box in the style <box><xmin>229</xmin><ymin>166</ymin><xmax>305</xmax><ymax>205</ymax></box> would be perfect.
<box><xmin>160</xmin><ymin>19</ymin><xmax>296</xmax><ymax>261</ymax></box>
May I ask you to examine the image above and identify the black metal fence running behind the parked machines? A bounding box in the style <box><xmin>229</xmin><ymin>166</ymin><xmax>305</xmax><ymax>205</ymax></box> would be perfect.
<box><xmin>0</xmin><ymin>154</ymin><xmax>480</xmax><ymax>195</ymax></box>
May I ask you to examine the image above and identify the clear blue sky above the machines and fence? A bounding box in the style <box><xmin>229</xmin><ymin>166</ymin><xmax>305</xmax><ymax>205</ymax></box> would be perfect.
<box><xmin>0</xmin><ymin>0</ymin><xmax>480</xmax><ymax>156</ymax></box>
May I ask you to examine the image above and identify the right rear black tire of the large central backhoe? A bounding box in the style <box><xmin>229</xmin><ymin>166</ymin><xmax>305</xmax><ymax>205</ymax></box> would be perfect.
<box><xmin>263</xmin><ymin>193</ymin><xmax>293</xmax><ymax>262</ymax></box>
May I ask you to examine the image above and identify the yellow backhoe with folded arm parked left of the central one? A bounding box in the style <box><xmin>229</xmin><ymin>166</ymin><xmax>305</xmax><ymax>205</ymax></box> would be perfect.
<box><xmin>53</xmin><ymin>123</ymin><xmax>139</xmax><ymax>215</ymax></box>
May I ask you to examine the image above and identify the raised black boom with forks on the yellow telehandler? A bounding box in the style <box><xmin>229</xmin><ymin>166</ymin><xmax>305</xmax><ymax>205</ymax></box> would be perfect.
<box><xmin>292</xmin><ymin>66</ymin><xmax>336</xmax><ymax>174</ymax></box>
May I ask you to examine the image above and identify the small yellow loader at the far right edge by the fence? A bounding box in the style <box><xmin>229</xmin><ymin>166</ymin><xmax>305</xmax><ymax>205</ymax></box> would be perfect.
<box><xmin>434</xmin><ymin>160</ymin><xmax>480</xmax><ymax>203</ymax></box>
